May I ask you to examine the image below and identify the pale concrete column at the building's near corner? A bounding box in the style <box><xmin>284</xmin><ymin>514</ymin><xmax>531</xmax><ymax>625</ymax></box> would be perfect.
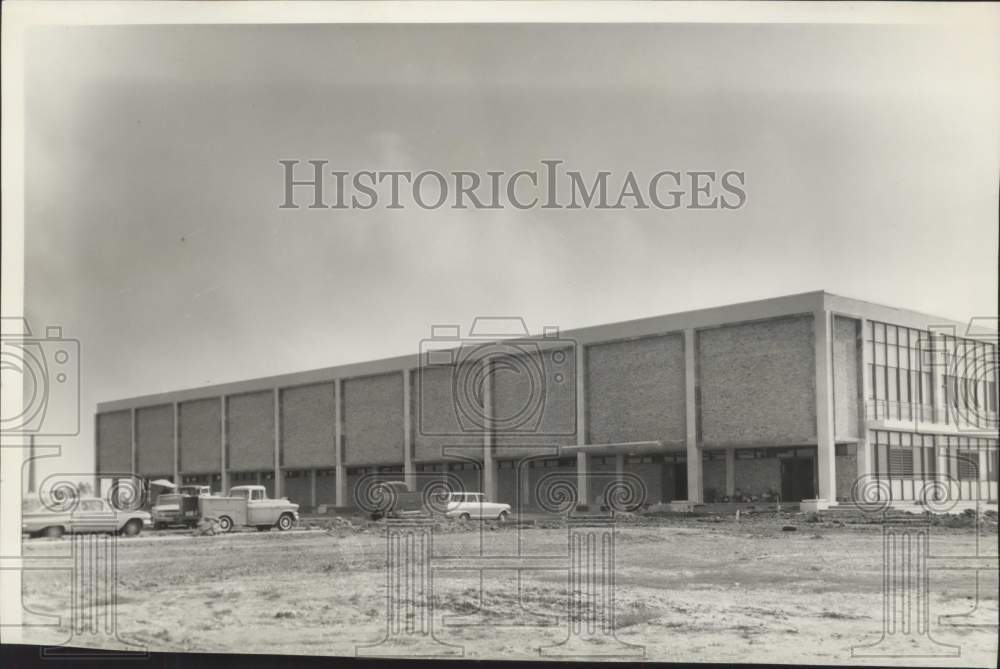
<box><xmin>813</xmin><ymin>309</ymin><xmax>837</xmax><ymax>504</ymax></box>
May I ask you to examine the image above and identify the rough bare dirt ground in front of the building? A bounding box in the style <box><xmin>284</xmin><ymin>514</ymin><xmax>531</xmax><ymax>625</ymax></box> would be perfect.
<box><xmin>15</xmin><ymin>514</ymin><xmax>998</xmax><ymax>667</ymax></box>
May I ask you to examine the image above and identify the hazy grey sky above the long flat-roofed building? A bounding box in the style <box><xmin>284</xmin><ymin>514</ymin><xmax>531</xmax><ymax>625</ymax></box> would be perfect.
<box><xmin>25</xmin><ymin>22</ymin><xmax>1000</xmax><ymax>480</ymax></box>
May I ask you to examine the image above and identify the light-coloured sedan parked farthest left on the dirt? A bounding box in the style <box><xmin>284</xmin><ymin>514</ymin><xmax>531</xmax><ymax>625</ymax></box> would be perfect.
<box><xmin>21</xmin><ymin>497</ymin><xmax>153</xmax><ymax>537</ymax></box>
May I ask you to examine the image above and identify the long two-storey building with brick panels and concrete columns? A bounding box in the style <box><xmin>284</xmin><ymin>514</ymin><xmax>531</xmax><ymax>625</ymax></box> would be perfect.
<box><xmin>95</xmin><ymin>292</ymin><xmax>997</xmax><ymax>507</ymax></box>
